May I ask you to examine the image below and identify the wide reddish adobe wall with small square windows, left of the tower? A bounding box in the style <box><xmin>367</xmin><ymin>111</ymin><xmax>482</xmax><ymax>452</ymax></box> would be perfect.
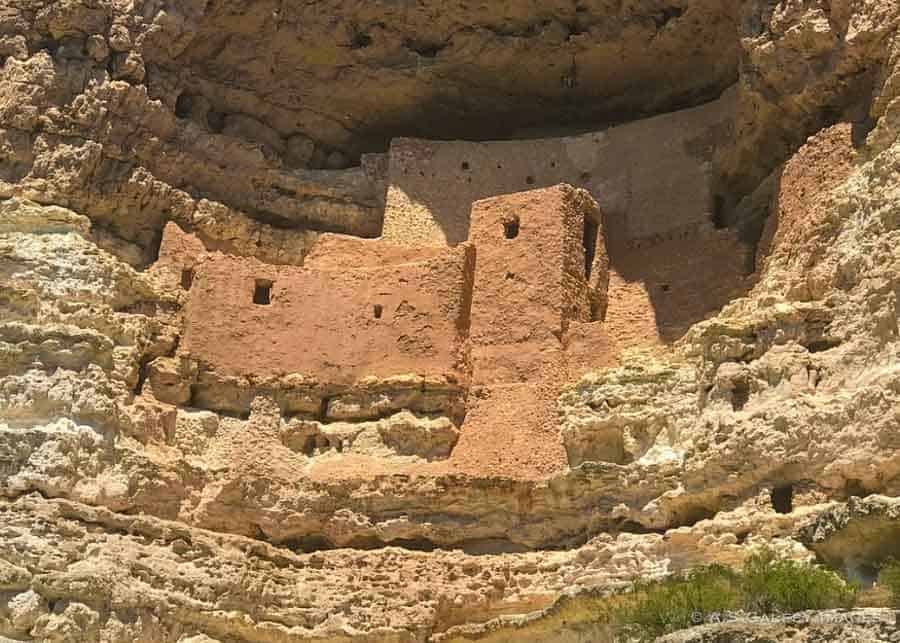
<box><xmin>169</xmin><ymin>229</ymin><xmax>474</xmax><ymax>385</ymax></box>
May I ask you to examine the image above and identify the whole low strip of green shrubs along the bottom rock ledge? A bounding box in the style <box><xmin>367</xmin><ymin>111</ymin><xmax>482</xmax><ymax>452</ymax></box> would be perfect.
<box><xmin>609</xmin><ymin>550</ymin><xmax>856</xmax><ymax>641</ymax></box>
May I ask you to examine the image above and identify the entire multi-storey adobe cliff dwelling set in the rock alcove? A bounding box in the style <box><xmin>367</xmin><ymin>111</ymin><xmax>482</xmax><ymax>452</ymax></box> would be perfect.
<box><xmin>148</xmin><ymin>95</ymin><xmax>754</xmax><ymax>478</ymax></box>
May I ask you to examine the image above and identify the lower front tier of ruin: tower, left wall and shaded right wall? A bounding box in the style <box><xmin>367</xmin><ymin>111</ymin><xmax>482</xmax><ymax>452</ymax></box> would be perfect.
<box><xmin>151</xmin><ymin>180</ymin><xmax>750</xmax><ymax>478</ymax></box>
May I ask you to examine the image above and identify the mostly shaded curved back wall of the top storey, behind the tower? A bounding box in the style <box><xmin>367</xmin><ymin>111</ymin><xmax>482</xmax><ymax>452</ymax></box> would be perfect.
<box><xmin>383</xmin><ymin>93</ymin><xmax>733</xmax><ymax>245</ymax></box>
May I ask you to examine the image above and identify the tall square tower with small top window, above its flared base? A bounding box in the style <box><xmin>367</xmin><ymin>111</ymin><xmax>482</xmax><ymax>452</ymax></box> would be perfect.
<box><xmin>470</xmin><ymin>185</ymin><xmax>606</xmax><ymax>383</ymax></box>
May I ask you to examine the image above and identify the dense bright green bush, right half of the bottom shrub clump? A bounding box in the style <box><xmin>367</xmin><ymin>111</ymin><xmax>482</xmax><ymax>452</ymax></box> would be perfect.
<box><xmin>743</xmin><ymin>550</ymin><xmax>857</xmax><ymax>614</ymax></box>
